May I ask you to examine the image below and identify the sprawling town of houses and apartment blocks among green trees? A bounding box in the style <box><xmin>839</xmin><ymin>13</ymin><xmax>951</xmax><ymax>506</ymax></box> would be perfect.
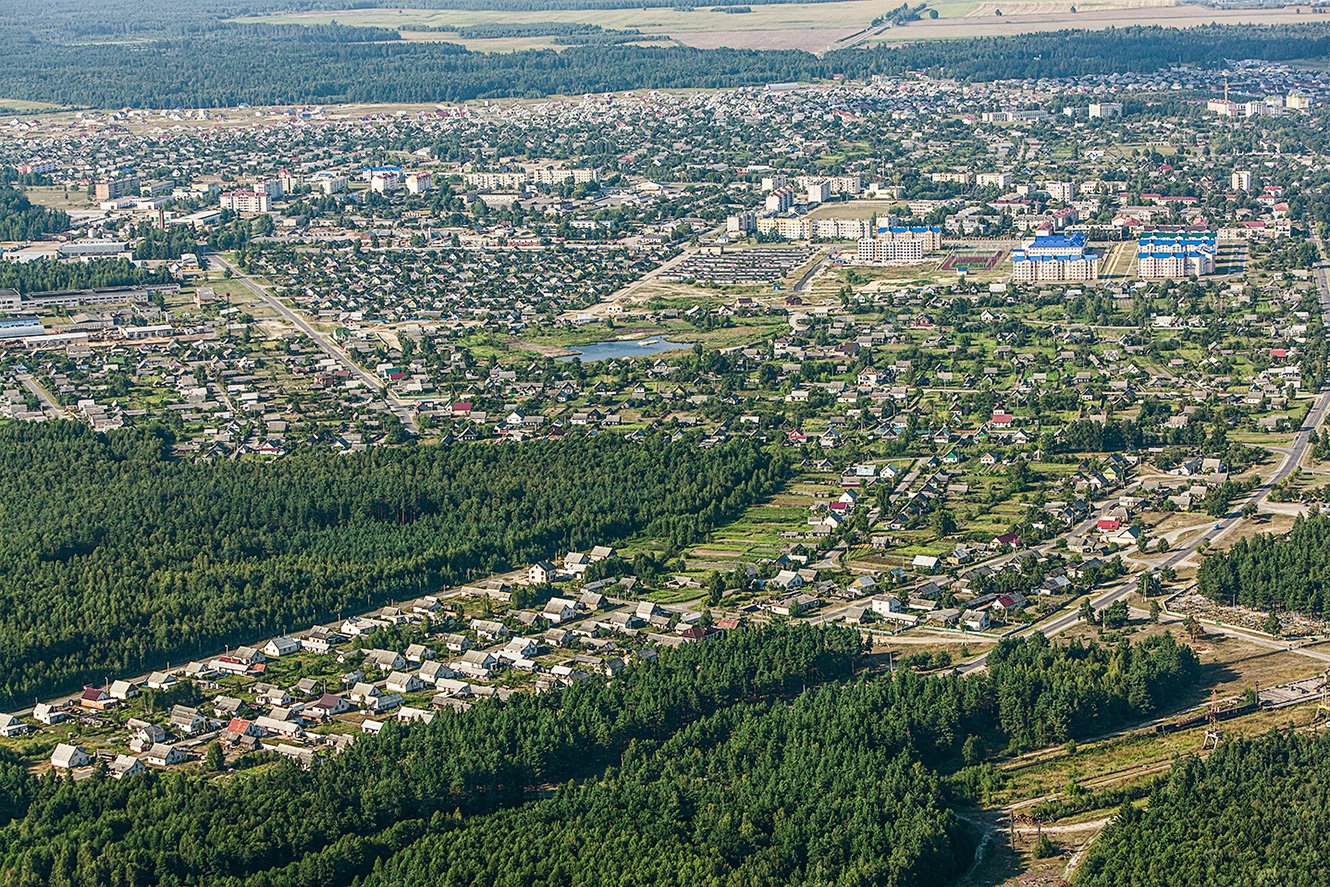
<box><xmin>0</xmin><ymin>50</ymin><xmax>1330</xmax><ymax>887</ymax></box>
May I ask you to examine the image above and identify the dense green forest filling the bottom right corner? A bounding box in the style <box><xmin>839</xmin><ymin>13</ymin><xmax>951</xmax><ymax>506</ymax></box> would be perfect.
<box><xmin>1076</xmin><ymin>733</ymin><xmax>1330</xmax><ymax>887</ymax></box>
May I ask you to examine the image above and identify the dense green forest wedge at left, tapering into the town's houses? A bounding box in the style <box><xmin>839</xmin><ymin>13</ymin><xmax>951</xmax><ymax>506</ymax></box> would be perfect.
<box><xmin>0</xmin><ymin>423</ymin><xmax>785</xmax><ymax>702</ymax></box>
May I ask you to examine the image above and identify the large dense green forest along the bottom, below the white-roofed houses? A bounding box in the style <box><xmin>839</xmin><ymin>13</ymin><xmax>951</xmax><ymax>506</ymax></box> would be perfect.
<box><xmin>0</xmin><ymin>624</ymin><xmax>1198</xmax><ymax>886</ymax></box>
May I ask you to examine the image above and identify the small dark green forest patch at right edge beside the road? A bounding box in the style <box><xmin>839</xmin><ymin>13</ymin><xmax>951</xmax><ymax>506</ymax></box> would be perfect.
<box><xmin>1196</xmin><ymin>515</ymin><xmax>1330</xmax><ymax>616</ymax></box>
